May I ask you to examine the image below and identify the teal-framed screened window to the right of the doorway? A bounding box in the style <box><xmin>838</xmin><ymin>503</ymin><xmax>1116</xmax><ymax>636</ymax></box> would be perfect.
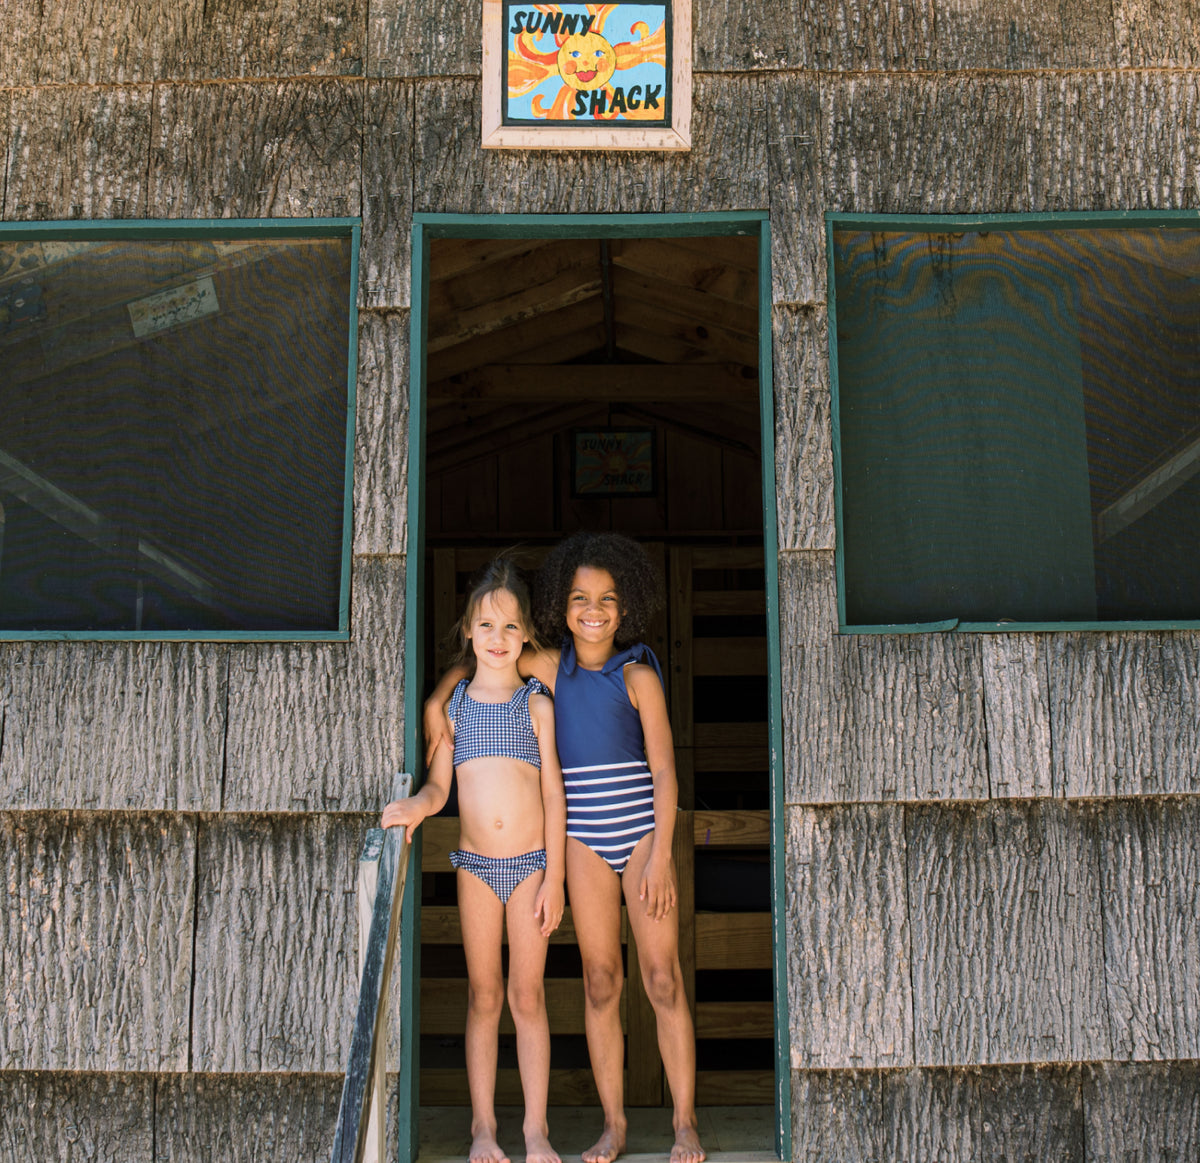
<box><xmin>829</xmin><ymin>215</ymin><xmax>1200</xmax><ymax>629</ymax></box>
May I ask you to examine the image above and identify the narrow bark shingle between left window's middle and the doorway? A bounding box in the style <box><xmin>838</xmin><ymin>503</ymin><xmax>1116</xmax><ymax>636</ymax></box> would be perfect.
<box><xmin>354</xmin><ymin>311</ymin><xmax>409</xmax><ymax>553</ymax></box>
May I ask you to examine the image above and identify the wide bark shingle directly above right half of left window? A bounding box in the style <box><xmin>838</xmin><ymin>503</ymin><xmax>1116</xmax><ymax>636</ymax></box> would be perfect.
<box><xmin>149</xmin><ymin>80</ymin><xmax>362</xmax><ymax>218</ymax></box>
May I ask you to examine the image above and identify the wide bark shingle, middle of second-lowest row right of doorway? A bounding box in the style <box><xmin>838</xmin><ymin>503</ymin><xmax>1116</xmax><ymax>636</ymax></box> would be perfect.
<box><xmin>907</xmin><ymin>801</ymin><xmax>1110</xmax><ymax>1066</ymax></box>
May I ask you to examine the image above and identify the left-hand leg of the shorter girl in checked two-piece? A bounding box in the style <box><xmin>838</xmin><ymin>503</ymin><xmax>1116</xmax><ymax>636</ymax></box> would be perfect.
<box><xmin>458</xmin><ymin>869</ymin><xmax>509</xmax><ymax>1163</ymax></box>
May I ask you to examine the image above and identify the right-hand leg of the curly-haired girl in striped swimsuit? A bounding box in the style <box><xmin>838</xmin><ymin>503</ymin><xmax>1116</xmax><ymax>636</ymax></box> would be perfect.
<box><xmin>622</xmin><ymin>833</ymin><xmax>704</xmax><ymax>1163</ymax></box>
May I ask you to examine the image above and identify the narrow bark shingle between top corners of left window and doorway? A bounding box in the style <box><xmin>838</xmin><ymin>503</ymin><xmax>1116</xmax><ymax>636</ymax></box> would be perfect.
<box><xmin>359</xmin><ymin>79</ymin><xmax>420</xmax><ymax>307</ymax></box>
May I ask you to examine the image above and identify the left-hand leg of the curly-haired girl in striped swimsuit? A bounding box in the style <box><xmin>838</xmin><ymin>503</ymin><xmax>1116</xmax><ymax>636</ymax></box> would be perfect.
<box><xmin>566</xmin><ymin>837</ymin><xmax>626</xmax><ymax>1163</ymax></box>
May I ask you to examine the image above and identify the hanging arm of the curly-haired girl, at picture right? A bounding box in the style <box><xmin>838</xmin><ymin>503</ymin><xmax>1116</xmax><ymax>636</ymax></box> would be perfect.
<box><xmin>625</xmin><ymin>663</ymin><xmax>679</xmax><ymax>921</ymax></box>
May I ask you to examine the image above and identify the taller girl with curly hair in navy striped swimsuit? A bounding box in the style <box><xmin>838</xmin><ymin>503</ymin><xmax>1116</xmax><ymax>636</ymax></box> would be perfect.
<box><xmin>425</xmin><ymin>533</ymin><xmax>704</xmax><ymax>1163</ymax></box>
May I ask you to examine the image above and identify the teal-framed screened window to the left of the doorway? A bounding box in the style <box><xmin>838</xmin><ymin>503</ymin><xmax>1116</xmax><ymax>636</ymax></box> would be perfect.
<box><xmin>0</xmin><ymin>220</ymin><xmax>358</xmax><ymax>639</ymax></box>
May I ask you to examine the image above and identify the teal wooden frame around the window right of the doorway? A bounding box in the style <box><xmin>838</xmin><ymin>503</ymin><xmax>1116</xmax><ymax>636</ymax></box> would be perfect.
<box><xmin>824</xmin><ymin>210</ymin><xmax>1200</xmax><ymax>634</ymax></box>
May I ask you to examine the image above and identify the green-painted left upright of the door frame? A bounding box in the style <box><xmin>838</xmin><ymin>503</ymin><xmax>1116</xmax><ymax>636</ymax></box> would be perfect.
<box><xmin>396</xmin><ymin>221</ymin><xmax>430</xmax><ymax>1163</ymax></box>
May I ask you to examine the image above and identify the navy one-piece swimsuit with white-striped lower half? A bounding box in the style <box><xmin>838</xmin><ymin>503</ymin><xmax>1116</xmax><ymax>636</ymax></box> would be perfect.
<box><xmin>554</xmin><ymin>637</ymin><xmax>662</xmax><ymax>874</ymax></box>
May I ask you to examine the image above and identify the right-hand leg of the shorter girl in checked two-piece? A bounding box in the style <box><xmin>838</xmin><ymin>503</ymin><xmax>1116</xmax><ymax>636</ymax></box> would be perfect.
<box><xmin>504</xmin><ymin>873</ymin><xmax>562</xmax><ymax>1163</ymax></box>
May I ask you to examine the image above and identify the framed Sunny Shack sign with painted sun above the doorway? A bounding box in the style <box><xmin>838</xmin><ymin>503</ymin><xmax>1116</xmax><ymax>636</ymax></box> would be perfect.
<box><xmin>484</xmin><ymin>0</ymin><xmax>691</xmax><ymax>150</ymax></box>
